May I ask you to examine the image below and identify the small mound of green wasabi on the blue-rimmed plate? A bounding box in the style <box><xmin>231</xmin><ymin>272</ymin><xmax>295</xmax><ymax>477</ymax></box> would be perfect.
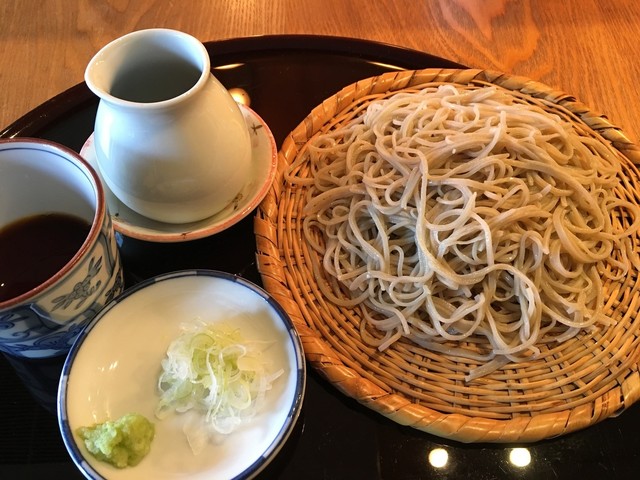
<box><xmin>76</xmin><ymin>413</ymin><xmax>155</xmax><ymax>468</ymax></box>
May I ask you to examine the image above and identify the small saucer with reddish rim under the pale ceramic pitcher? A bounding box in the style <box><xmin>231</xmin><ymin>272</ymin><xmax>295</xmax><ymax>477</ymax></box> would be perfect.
<box><xmin>80</xmin><ymin>104</ymin><xmax>278</xmax><ymax>243</ymax></box>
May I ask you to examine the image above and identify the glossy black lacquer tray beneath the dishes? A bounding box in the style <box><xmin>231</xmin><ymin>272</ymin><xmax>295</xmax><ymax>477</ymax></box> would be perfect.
<box><xmin>0</xmin><ymin>35</ymin><xmax>640</xmax><ymax>480</ymax></box>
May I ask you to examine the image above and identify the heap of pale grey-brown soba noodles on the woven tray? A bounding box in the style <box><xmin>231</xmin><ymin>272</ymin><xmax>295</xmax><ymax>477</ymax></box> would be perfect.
<box><xmin>286</xmin><ymin>84</ymin><xmax>640</xmax><ymax>380</ymax></box>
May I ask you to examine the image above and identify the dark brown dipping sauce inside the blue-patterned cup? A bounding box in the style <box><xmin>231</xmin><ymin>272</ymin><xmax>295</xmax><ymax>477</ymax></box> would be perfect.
<box><xmin>0</xmin><ymin>213</ymin><xmax>91</xmax><ymax>302</ymax></box>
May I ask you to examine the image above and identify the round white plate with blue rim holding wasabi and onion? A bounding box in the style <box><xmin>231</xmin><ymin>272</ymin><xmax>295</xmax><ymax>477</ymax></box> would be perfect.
<box><xmin>58</xmin><ymin>270</ymin><xmax>306</xmax><ymax>480</ymax></box>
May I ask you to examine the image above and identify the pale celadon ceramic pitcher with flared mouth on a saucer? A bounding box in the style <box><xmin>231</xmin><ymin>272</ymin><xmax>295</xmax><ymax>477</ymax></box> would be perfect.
<box><xmin>85</xmin><ymin>29</ymin><xmax>251</xmax><ymax>223</ymax></box>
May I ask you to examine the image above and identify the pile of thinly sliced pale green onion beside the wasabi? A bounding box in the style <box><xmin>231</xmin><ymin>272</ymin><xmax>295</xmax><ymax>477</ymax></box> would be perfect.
<box><xmin>156</xmin><ymin>322</ymin><xmax>283</xmax><ymax>454</ymax></box>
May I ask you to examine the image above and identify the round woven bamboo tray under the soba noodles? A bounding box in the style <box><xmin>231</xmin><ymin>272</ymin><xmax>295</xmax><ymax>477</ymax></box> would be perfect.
<box><xmin>254</xmin><ymin>69</ymin><xmax>640</xmax><ymax>442</ymax></box>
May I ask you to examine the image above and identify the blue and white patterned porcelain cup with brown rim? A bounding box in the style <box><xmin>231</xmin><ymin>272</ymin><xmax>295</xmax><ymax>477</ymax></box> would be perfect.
<box><xmin>0</xmin><ymin>138</ymin><xmax>124</xmax><ymax>358</ymax></box>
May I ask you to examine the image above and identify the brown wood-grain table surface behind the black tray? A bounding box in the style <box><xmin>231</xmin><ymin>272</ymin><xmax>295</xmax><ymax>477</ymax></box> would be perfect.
<box><xmin>0</xmin><ymin>0</ymin><xmax>640</xmax><ymax>142</ymax></box>
